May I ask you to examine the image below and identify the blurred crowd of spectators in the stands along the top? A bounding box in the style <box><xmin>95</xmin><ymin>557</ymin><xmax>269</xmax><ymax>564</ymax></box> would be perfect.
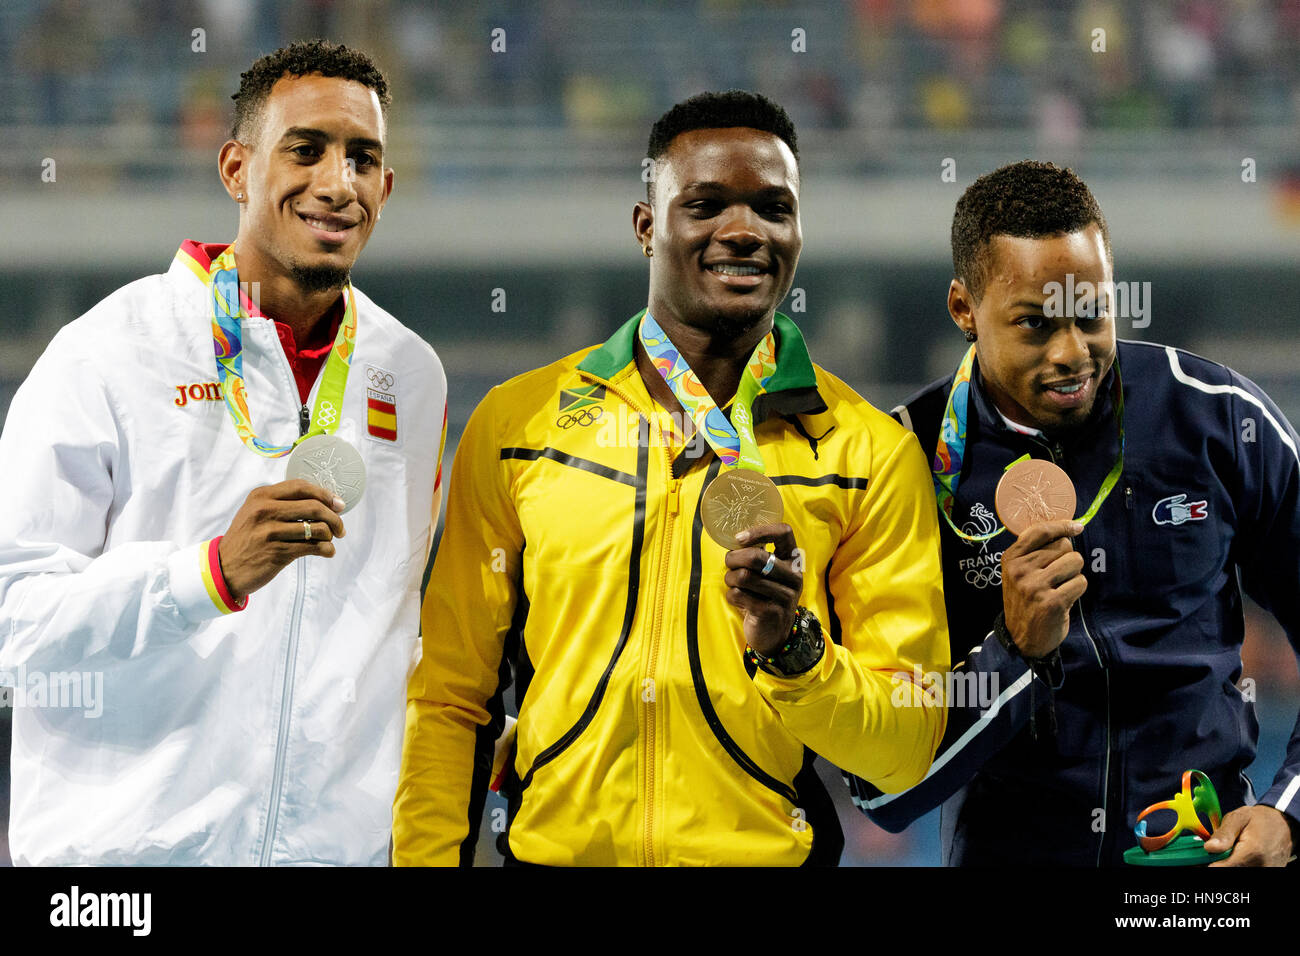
<box><xmin>0</xmin><ymin>0</ymin><xmax>1300</xmax><ymax>158</ymax></box>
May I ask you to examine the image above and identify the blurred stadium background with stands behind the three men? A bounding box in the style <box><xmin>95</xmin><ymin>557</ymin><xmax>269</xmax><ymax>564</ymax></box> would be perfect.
<box><xmin>0</xmin><ymin>0</ymin><xmax>1300</xmax><ymax>864</ymax></box>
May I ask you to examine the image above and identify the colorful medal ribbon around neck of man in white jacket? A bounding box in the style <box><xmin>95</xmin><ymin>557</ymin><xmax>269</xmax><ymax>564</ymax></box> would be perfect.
<box><xmin>208</xmin><ymin>243</ymin><xmax>356</xmax><ymax>458</ymax></box>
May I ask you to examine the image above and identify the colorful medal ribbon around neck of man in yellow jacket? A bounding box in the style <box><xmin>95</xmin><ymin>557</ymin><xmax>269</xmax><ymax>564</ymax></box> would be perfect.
<box><xmin>637</xmin><ymin>310</ymin><xmax>776</xmax><ymax>472</ymax></box>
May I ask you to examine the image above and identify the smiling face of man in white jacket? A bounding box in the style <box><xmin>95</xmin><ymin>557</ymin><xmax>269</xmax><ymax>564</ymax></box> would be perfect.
<box><xmin>221</xmin><ymin>74</ymin><xmax>393</xmax><ymax>291</ymax></box>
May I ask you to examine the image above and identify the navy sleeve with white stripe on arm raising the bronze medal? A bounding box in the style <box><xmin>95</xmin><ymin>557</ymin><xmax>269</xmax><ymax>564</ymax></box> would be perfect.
<box><xmin>844</xmin><ymin>632</ymin><xmax>1050</xmax><ymax>832</ymax></box>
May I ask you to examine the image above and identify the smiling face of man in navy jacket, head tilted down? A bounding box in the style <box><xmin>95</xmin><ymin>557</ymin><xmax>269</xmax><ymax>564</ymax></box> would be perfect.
<box><xmin>948</xmin><ymin>224</ymin><xmax>1115</xmax><ymax>433</ymax></box>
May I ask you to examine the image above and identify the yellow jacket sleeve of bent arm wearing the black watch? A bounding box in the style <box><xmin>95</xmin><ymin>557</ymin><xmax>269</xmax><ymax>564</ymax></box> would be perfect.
<box><xmin>754</xmin><ymin>428</ymin><xmax>949</xmax><ymax>793</ymax></box>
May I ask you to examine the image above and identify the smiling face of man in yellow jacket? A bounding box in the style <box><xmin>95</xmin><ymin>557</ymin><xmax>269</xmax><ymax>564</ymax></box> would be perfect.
<box><xmin>633</xmin><ymin>126</ymin><xmax>803</xmax><ymax>338</ymax></box>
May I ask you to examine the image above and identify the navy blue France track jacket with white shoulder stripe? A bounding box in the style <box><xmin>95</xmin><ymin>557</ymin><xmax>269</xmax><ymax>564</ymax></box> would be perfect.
<box><xmin>848</xmin><ymin>341</ymin><xmax>1300</xmax><ymax>866</ymax></box>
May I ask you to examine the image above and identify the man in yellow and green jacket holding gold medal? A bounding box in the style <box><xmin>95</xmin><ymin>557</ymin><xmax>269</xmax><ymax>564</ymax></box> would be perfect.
<box><xmin>394</xmin><ymin>91</ymin><xmax>949</xmax><ymax>865</ymax></box>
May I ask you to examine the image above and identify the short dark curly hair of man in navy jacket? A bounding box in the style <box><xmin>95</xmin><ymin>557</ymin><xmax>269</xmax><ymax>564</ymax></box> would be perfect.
<box><xmin>953</xmin><ymin>160</ymin><xmax>1114</xmax><ymax>302</ymax></box>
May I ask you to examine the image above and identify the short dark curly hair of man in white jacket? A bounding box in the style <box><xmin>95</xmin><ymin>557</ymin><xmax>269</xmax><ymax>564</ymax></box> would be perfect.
<box><xmin>230</xmin><ymin>39</ymin><xmax>393</xmax><ymax>140</ymax></box>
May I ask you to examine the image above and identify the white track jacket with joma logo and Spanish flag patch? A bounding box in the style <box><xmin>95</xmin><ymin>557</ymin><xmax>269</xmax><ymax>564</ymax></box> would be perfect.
<box><xmin>0</xmin><ymin>243</ymin><xmax>447</xmax><ymax>865</ymax></box>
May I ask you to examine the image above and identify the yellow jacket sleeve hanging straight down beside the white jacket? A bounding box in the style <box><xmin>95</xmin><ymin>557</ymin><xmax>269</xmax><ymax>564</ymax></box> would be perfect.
<box><xmin>393</xmin><ymin>393</ymin><xmax>524</xmax><ymax>866</ymax></box>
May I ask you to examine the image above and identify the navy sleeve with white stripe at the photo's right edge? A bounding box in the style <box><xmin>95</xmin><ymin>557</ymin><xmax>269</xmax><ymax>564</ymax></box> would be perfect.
<box><xmin>1231</xmin><ymin>373</ymin><xmax>1300</xmax><ymax>822</ymax></box>
